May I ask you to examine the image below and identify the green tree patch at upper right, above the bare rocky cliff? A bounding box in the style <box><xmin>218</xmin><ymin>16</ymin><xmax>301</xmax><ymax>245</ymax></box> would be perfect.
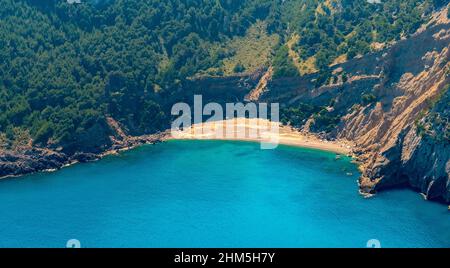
<box><xmin>281</xmin><ymin>0</ymin><xmax>441</xmax><ymax>79</ymax></box>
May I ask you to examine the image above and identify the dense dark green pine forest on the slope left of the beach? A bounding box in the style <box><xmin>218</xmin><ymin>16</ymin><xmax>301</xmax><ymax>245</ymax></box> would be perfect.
<box><xmin>0</xmin><ymin>0</ymin><xmax>274</xmax><ymax>151</ymax></box>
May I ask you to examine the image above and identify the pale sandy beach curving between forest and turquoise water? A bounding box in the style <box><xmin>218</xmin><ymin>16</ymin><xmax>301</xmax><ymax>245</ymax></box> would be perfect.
<box><xmin>167</xmin><ymin>118</ymin><xmax>353</xmax><ymax>155</ymax></box>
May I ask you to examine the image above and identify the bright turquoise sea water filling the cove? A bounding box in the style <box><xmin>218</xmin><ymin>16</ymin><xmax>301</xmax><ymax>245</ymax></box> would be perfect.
<box><xmin>0</xmin><ymin>141</ymin><xmax>450</xmax><ymax>247</ymax></box>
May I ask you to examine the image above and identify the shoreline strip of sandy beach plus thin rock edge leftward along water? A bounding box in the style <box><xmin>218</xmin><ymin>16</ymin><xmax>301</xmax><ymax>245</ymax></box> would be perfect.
<box><xmin>0</xmin><ymin>118</ymin><xmax>354</xmax><ymax>179</ymax></box>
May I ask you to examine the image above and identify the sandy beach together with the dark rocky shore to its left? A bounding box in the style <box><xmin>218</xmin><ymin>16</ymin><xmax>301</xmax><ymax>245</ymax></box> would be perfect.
<box><xmin>0</xmin><ymin>118</ymin><xmax>354</xmax><ymax>180</ymax></box>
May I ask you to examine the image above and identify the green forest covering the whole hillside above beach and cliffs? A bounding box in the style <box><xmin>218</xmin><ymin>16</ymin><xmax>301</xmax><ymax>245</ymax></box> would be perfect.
<box><xmin>0</xmin><ymin>0</ymin><xmax>447</xmax><ymax>153</ymax></box>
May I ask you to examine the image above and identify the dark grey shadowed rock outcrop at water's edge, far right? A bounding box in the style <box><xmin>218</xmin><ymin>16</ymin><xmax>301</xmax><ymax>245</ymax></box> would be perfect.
<box><xmin>368</xmin><ymin>124</ymin><xmax>450</xmax><ymax>202</ymax></box>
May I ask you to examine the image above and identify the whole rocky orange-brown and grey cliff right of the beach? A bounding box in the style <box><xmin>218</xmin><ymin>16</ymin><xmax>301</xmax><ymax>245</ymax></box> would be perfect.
<box><xmin>260</xmin><ymin>10</ymin><xmax>450</xmax><ymax>203</ymax></box>
